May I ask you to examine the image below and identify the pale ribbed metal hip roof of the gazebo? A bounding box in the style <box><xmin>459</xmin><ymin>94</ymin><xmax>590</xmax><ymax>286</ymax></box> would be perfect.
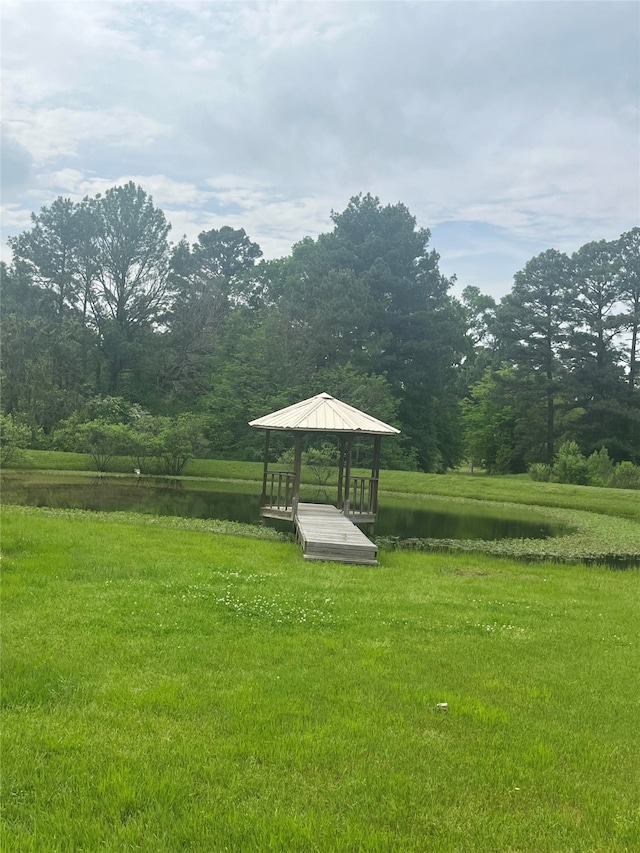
<box><xmin>249</xmin><ymin>394</ymin><xmax>400</xmax><ymax>435</ymax></box>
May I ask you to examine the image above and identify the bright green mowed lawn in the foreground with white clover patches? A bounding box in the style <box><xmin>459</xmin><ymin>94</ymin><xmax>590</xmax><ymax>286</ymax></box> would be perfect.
<box><xmin>2</xmin><ymin>508</ymin><xmax>640</xmax><ymax>853</ymax></box>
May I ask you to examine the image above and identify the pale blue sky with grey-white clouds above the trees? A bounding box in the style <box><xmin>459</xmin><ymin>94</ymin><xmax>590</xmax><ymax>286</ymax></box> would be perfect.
<box><xmin>0</xmin><ymin>0</ymin><xmax>640</xmax><ymax>298</ymax></box>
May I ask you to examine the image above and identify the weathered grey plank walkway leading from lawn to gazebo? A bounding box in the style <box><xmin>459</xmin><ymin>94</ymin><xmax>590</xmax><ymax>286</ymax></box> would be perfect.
<box><xmin>295</xmin><ymin>503</ymin><xmax>378</xmax><ymax>566</ymax></box>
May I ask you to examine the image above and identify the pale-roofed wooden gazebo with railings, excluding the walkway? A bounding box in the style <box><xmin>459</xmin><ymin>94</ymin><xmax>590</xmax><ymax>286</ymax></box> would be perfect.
<box><xmin>249</xmin><ymin>393</ymin><xmax>400</xmax><ymax>525</ymax></box>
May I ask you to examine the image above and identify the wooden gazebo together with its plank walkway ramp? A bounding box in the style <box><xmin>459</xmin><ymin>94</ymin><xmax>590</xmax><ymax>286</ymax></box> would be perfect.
<box><xmin>249</xmin><ymin>394</ymin><xmax>399</xmax><ymax>565</ymax></box>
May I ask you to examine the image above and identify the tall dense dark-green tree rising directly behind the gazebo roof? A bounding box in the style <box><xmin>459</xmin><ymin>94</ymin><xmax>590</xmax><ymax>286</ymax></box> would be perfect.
<box><xmin>283</xmin><ymin>194</ymin><xmax>465</xmax><ymax>470</ymax></box>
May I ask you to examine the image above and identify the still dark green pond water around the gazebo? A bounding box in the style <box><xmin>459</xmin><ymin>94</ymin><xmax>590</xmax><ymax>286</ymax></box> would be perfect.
<box><xmin>2</xmin><ymin>472</ymin><xmax>562</xmax><ymax>540</ymax></box>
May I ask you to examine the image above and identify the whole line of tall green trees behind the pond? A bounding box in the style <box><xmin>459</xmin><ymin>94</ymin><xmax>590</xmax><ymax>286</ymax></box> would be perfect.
<box><xmin>1</xmin><ymin>183</ymin><xmax>640</xmax><ymax>473</ymax></box>
